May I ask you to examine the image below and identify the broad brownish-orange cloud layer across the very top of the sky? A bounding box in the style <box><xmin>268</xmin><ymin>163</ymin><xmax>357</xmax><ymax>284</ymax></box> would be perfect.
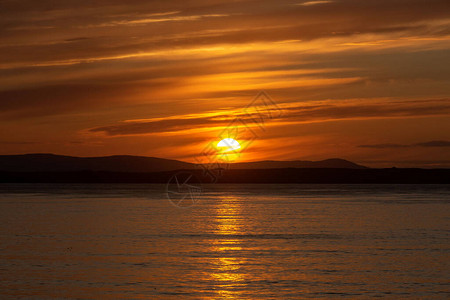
<box><xmin>0</xmin><ymin>0</ymin><xmax>450</xmax><ymax>67</ymax></box>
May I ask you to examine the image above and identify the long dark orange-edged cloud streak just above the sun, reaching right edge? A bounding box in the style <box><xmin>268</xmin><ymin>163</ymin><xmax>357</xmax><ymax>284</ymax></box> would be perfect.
<box><xmin>89</xmin><ymin>99</ymin><xmax>450</xmax><ymax>136</ymax></box>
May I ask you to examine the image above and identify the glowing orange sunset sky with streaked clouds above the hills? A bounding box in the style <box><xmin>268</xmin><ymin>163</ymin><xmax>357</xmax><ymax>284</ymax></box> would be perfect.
<box><xmin>0</xmin><ymin>0</ymin><xmax>450</xmax><ymax>167</ymax></box>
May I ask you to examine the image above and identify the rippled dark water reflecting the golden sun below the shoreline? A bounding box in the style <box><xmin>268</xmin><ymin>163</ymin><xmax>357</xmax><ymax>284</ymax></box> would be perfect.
<box><xmin>0</xmin><ymin>184</ymin><xmax>450</xmax><ymax>299</ymax></box>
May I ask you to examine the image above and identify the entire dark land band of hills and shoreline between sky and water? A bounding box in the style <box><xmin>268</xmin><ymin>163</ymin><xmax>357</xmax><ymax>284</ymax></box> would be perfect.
<box><xmin>0</xmin><ymin>154</ymin><xmax>450</xmax><ymax>184</ymax></box>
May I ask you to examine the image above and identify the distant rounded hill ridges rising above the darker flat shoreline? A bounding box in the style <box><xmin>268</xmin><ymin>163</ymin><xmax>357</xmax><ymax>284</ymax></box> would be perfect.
<box><xmin>0</xmin><ymin>154</ymin><xmax>366</xmax><ymax>173</ymax></box>
